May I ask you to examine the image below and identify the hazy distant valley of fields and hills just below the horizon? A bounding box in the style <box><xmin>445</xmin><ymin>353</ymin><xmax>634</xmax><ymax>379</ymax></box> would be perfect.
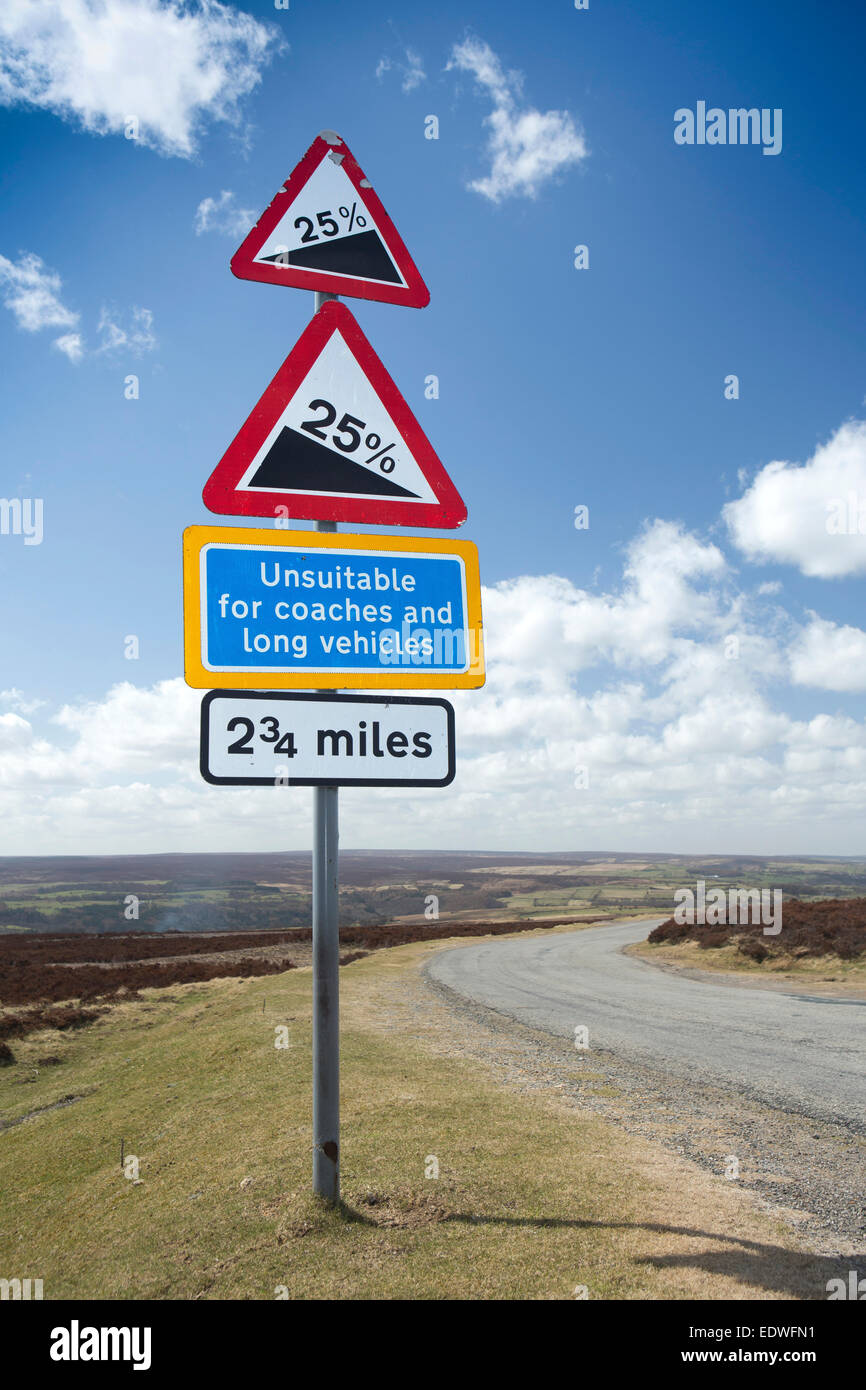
<box><xmin>0</xmin><ymin>851</ymin><xmax>866</xmax><ymax>934</ymax></box>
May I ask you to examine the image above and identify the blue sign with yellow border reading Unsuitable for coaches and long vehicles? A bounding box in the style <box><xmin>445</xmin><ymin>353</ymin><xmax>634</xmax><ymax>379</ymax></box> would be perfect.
<box><xmin>180</xmin><ymin>527</ymin><xmax>484</xmax><ymax>688</ymax></box>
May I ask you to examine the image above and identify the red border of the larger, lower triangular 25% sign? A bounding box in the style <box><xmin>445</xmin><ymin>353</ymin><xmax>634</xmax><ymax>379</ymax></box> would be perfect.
<box><xmin>202</xmin><ymin>300</ymin><xmax>467</xmax><ymax>530</ymax></box>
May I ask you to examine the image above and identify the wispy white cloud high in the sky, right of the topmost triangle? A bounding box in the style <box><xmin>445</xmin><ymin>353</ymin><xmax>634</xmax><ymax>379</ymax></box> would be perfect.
<box><xmin>448</xmin><ymin>38</ymin><xmax>589</xmax><ymax>203</ymax></box>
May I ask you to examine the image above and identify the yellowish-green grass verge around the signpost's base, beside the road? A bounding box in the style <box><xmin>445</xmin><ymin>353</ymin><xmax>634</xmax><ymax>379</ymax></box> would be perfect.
<box><xmin>0</xmin><ymin>941</ymin><xmax>837</xmax><ymax>1300</ymax></box>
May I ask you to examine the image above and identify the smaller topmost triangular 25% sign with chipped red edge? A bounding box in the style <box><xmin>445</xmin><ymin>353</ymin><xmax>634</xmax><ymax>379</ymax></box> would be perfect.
<box><xmin>232</xmin><ymin>131</ymin><xmax>430</xmax><ymax>309</ymax></box>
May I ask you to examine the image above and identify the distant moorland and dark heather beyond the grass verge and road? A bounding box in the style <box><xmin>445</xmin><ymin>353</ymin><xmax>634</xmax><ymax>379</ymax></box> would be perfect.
<box><xmin>0</xmin><ymin>852</ymin><xmax>866</xmax><ymax>1050</ymax></box>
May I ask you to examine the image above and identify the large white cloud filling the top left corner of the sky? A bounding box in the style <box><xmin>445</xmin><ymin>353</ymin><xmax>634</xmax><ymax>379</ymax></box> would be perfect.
<box><xmin>0</xmin><ymin>0</ymin><xmax>279</xmax><ymax>157</ymax></box>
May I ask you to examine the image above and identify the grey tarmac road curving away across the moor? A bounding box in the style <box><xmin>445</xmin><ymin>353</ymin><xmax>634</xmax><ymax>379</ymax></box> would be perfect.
<box><xmin>427</xmin><ymin>920</ymin><xmax>866</xmax><ymax>1133</ymax></box>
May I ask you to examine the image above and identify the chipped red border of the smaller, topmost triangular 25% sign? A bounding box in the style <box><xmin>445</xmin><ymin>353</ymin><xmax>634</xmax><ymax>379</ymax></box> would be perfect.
<box><xmin>231</xmin><ymin>131</ymin><xmax>430</xmax><ymax>309</ymax></box>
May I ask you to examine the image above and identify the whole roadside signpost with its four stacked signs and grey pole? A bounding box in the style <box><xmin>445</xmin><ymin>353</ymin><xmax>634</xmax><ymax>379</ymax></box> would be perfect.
<box><xmin>183</xmin><ymin>131</ymin><xmax>484</xmax><ymax>1204</ymax></box>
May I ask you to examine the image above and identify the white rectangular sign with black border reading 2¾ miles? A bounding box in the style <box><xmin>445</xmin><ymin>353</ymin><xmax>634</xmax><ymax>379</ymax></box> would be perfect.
<box><xmin>200</xmin><ymin>691</ymin><xmax>455</xmax><ymax>787</ymax></box>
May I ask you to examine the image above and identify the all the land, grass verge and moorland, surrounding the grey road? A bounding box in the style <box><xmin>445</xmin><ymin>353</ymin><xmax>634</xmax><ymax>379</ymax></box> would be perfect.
<box><xmin>0</xmin><ymin>853</ymin><xmax>866</xmax><ymax>1300</ymax></box>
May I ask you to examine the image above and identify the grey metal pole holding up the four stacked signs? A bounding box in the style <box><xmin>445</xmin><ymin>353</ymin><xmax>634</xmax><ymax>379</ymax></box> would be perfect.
<box><xmin>313</xmin><ymin>291</ymin><xmax>339</xmax><ymax>1202</ymax></box>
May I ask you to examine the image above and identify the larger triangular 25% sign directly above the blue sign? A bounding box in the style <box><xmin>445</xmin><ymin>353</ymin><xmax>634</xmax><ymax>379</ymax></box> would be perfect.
<box><xmin>203</xmin><ymin>299</ymin><xmax>466</xmax><ymax>530</ymax></box>
